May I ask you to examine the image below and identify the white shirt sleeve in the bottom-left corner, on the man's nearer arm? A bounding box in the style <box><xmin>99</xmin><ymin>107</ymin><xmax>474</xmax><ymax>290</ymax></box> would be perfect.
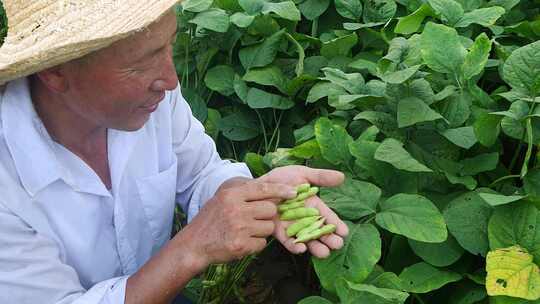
<box><xmin>0</xmin><ymin>203</ymin><xmax>127</xmax><ymax>304</ymax></box>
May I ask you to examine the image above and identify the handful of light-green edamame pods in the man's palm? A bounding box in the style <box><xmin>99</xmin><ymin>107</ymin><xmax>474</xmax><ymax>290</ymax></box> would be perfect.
<box><xmin>278</xmin><ymin>184</ymin><xmax>336</xmax><ymax>243</ymax></box>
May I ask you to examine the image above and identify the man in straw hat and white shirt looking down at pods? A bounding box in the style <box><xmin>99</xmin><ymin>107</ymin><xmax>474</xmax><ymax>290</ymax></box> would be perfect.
<box><xmin>0</xmin><ymin>0</ymin><xmax>348</xmax><ymax>304</ymax></box>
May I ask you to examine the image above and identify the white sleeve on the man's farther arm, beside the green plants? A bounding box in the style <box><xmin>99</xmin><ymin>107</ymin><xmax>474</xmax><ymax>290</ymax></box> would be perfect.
<box><xmin>171</xmin><ymin>86</ymin><xmax>252</xmax><ymax>221</ymax></box>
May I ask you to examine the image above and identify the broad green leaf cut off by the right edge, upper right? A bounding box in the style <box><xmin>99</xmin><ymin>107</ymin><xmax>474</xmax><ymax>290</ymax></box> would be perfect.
<box><xmin>503</xmin><ymin>41</ymin><xmax>540</xmax><ymax>96</ymax></box>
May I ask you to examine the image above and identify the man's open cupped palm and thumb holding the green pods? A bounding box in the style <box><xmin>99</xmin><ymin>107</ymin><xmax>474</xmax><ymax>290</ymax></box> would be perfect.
<box><xmin>257</xmin><ymin>166</ymin><xmax>349</xmax><ymax>258</ymax></box>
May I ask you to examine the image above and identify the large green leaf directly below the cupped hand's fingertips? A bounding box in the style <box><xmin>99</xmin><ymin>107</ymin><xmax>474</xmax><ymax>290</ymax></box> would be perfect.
<box><xmin>312</xmin><ymin>222</ymin><xmax>381</xmax><ymax>293</ymax></box>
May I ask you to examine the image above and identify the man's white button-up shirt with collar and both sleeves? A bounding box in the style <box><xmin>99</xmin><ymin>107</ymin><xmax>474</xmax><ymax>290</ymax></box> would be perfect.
<box><xmin>0</xmin><ymin>78</ymin><xmax>251</xmax><ymax>304</ymax></box>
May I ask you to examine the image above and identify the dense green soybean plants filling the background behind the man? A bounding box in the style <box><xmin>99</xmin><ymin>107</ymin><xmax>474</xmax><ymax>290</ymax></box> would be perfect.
<box><xmin>0</xmin><ymin>0</ymin><xmax>540</xmax><ymax>304</ymax></box>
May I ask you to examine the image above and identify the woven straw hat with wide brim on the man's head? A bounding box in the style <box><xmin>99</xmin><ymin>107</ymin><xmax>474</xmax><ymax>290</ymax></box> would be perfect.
<box><xmin>0</xmin><ymin>0</ymin><xmax>179</xmax><ymax>85</ymax></box>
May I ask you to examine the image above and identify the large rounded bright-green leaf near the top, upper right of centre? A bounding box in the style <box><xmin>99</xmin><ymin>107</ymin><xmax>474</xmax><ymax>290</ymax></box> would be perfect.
<box><xmin>420</xmin><ymin>22</ymin><xmax>467</xmax><ymax>74</ymax></box>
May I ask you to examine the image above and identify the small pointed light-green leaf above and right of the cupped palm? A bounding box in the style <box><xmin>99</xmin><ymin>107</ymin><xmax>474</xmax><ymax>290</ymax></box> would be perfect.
<box><xmin>375</xmin><ymin>138</ymin><xmax>433</xmax><ymax>172</ymax></box>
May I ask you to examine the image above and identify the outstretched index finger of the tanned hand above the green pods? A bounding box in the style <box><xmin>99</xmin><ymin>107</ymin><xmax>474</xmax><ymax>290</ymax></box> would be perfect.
<box><xmin>235</xmin><ymin>181</ymin><xmax>297</xmax><ymax>202</ymax></box>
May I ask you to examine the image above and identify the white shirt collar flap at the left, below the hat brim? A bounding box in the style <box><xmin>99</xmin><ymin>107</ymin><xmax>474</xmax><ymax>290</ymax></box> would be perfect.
<box><xmin>0</xmin><ymin>78</ymin><xmax>69</xmax><ymax>196</ymax></box>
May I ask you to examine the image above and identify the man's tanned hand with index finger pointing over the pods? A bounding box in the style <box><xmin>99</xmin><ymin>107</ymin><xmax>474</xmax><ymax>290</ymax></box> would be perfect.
<box><xmin>177</xmin><ymin>180</ymin><xmax>296</xmax><ymax>268</ymax></box>
